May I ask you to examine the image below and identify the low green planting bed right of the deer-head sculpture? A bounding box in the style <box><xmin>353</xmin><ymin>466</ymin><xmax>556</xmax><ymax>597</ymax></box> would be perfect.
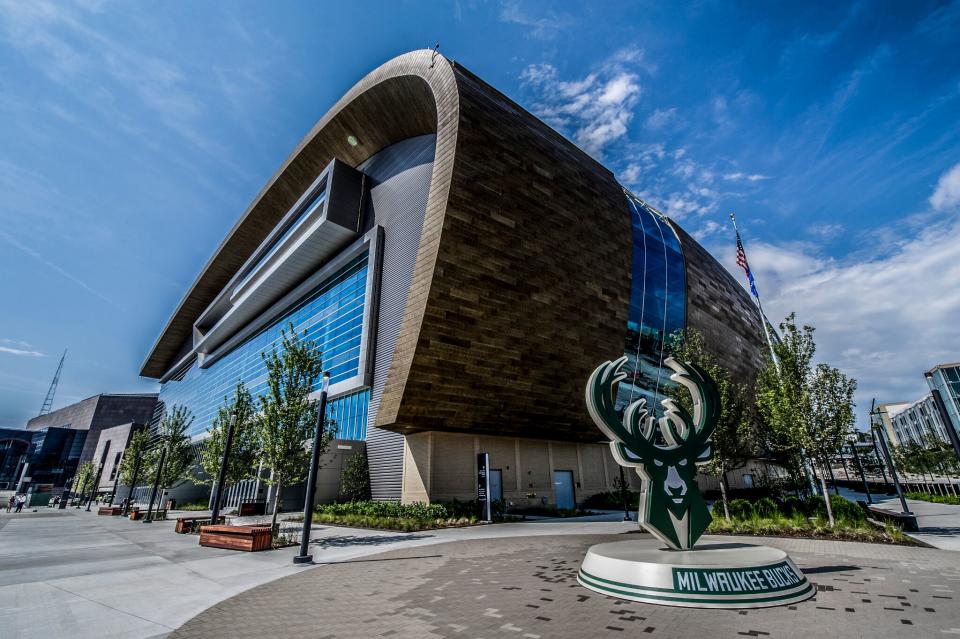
<box><xmin>706</xmin><ymin>495</ymin><xmax>922</xmax><ymax>546</ymax></box>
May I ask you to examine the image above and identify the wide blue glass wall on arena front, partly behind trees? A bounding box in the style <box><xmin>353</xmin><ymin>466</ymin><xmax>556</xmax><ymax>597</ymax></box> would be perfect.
<box><xmin>160</xmin><ymin>254</ymin><xmax>370</xmax><ymax>439</ymax></box>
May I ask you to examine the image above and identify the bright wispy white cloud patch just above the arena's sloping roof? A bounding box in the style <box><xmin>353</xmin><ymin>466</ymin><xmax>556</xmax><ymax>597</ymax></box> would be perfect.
<box><xmin>520</xmin><ymin>49</ymin><xmax>642</xmax><ymax>159</ymax></box>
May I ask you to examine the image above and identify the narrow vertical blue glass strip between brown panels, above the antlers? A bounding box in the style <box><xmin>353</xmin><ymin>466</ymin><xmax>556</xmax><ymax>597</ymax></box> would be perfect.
<box><xmin>617</xmin><ymin>193</ymin><xmax>686</xmax><ymax>410</ymax></box>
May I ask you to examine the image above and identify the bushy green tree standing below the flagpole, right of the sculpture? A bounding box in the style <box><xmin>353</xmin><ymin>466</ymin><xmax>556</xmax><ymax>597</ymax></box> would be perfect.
<box><xmin>757</xmin><ymin>313</ymin><xmax>857</xmax><ymax>526</ymax></box>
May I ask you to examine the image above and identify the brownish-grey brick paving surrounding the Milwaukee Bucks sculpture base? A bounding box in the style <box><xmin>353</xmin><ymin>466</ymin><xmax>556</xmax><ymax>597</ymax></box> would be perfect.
<box><xmin>171</xmin><ymin>535</ymin><xmax>960</xmax><ymax>639</ymax></box>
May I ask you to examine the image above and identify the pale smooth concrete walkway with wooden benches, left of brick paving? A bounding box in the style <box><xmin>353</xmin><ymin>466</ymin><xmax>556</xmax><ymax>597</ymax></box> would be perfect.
<box><xmin>0</xmin><ymin>509</ymin><xmax>637</xmax><ymax>639</ymax></box>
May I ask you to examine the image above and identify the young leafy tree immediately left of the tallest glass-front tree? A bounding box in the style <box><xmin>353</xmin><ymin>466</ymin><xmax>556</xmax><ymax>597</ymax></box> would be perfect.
<box><xmin>197</xmin><ymin>382</ymin><xmax>259</xmax><ymax>491</ymax></box>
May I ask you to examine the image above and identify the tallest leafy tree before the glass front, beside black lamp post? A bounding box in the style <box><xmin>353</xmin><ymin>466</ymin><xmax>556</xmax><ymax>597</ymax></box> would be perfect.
<box><xmin>256</xmin><ymin>324</ymin><xmax>332</xmax><ymax>529</ymax></box>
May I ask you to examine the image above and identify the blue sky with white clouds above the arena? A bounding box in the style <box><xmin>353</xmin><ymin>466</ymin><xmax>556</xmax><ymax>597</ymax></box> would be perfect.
<box><xmin>0</xmin><ymin>0</ymin><xmax>960</xmax><ymax>427</ymax></box>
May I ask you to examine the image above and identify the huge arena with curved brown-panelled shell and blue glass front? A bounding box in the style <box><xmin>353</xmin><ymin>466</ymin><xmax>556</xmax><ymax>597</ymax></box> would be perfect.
<box><xmin>141</xmin><ymin>51</ymin><xmax>764</xmax><ymax>506</ymax></box>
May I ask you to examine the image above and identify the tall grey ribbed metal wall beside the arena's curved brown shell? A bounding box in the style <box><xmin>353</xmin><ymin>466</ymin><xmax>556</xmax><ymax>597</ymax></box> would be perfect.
<box><xmin>359</xmin><ymin>135</ymin><xmax>436</xmax><ymax>500</ymax></box>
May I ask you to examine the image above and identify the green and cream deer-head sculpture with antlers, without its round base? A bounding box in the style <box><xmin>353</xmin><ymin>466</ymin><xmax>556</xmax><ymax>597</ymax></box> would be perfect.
<box><xmin>586</xmin><ymin>357</ymin><xmax>720</xmax><ymax>550</ymax></box>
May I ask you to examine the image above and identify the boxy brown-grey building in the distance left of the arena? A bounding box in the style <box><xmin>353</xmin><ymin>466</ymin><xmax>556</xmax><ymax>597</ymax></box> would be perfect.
<box><xmin>27</xmin><ymin>393</ymin><xmax>157</xmax><ymax>463</ymax></box>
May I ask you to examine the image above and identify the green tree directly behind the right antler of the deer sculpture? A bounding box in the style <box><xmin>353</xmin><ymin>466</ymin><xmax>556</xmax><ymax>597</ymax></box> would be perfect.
<box><xmin>667</xmin><ymin>328</ymin><xmax>760</xmax><ymax>519</ymax></box>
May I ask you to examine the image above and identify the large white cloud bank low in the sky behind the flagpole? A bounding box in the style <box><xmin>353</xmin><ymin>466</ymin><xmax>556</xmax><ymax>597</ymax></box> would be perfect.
<box><xmin>722</xmin><ymin>217</ymin><xmax>960</xmax><ymax>422</ymax></box>
